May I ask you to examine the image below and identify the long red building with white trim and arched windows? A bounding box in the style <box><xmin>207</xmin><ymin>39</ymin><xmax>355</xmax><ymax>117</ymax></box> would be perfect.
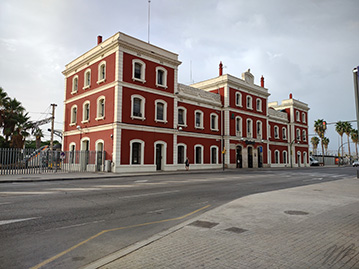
<box><xmin>63</xmin><ymin>33</ymin><xmax>309</xmax><ymax>172</ymax></box>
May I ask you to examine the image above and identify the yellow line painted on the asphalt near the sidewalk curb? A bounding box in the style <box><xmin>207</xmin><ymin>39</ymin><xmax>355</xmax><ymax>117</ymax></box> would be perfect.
<box><xmin>31</xmin><ymin>205</ymin><xmax>211</xmax><ymax>269</ymax></box>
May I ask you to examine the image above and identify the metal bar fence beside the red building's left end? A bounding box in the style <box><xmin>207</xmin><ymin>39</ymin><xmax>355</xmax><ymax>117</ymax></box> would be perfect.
<box><xmin>0</xmin><ymin>146</ymin><xmax>106</xmax><ymax>175</ymax></box>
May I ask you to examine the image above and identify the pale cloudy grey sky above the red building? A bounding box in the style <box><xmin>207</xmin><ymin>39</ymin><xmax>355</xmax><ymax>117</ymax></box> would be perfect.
<box><xmin>0</xmin><ymin>0</ymin><xmax>359</xmax><ymax>152</ymax></box>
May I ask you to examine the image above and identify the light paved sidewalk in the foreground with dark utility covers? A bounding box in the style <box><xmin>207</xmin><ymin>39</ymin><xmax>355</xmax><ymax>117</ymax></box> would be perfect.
<box><xmin>86</xmin><ymin>177</ymin><xmax>359</xmax><ymax>269</ymax></box>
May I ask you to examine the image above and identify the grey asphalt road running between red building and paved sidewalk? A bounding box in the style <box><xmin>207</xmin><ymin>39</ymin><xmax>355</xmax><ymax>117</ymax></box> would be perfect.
<box><xmin>0</xmin><ymin>167</ymin><xmax>357</xmax><ymax>268</ymax></box>
